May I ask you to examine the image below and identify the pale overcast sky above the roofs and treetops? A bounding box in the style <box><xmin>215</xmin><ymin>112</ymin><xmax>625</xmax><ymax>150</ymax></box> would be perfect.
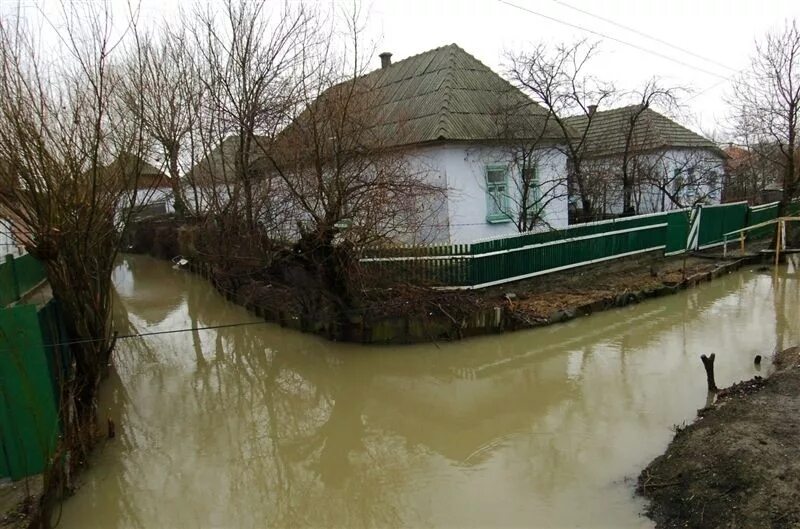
<box><xmin>6</xmin><ymin>0</ymin><xmax>800</xmax><ymax>138</ymax></box>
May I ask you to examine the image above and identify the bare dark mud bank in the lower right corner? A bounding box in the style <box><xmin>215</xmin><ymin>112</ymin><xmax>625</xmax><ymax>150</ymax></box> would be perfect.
<box><xmin>638</xmin><ymin>347</ymin><xmax>800</xmax><ymax>528</ymax></box>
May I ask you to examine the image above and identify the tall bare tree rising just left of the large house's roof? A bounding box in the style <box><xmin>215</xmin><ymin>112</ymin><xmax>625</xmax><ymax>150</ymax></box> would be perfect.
<box><xmin>191</xmin><ymin>0</ymin><xmax>309</xmax><ymax>231</ymax></box>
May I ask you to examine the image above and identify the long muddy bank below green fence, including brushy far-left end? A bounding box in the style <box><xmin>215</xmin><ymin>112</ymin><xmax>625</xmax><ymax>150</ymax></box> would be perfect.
<box><xmin>129</xmin><ymin>220</ymin><xmax>760</xmax><ymax>344</ymax></box>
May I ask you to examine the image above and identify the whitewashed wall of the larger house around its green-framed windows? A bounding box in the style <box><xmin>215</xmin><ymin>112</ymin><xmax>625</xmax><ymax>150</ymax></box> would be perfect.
<box><xmin>409</xmin><ymin>144</ymin><xmax>568</xmax><ymax>244</ymax></box>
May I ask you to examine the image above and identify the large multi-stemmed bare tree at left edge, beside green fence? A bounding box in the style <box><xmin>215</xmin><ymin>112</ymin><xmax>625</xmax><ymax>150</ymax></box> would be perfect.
<box><xmin>0</xmin><ymin>2</ymin><xmax>145</xmax><ymax>480</ymax></box>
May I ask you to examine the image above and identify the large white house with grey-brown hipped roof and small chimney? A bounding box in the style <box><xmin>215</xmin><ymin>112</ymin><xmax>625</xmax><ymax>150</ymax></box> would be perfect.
<box><xmin>192</xmin><ymin>44</ymin><xmax>568</xmax><ymax>243</ymax></box>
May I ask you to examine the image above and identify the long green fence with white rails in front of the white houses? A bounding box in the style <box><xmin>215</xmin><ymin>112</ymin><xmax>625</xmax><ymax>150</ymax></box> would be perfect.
<box><xmin>360</xmin><ymin>202</ymin><xmax>788</xmax><ymax>288</ymax></box>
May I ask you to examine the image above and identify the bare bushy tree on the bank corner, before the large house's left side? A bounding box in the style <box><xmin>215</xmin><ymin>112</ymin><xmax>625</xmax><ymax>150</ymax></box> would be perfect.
<box><xmin>270</xmin><ymin>9</ymin><xmax>444</xmax><ymax>317</ymax></box>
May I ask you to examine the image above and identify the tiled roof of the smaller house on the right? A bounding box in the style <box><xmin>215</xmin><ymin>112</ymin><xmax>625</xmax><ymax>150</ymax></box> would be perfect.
<box><xmin>566</xmin><ymin>105</ymin><xmax>724</xmax><ymax>157</ymax></box>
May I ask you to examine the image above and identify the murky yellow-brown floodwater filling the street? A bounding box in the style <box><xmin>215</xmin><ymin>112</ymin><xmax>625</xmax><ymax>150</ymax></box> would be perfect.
<box><xmin>59</xmin><ymin>256</ymin><xmax>800</xmax><ymax>528</ymax></box>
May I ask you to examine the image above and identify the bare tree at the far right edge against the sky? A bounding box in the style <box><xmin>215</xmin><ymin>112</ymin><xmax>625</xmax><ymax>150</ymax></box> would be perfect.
<box><xmin>730</xmin><ymin>20</ymin><xmax>800</xmax><ymax>215</ymax></box>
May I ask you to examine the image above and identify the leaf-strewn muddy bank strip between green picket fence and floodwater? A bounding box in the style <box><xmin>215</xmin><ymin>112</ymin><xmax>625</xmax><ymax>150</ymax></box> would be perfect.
<box><xmin>189</xmin><ymin>251</ymin><xmax>758</xmax><ymax>343</ymax></box>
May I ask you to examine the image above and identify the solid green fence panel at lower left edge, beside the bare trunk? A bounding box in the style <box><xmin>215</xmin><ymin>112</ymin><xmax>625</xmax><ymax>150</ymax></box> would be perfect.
<box><xmin>0</xmin><ymin>305</ymin><xmax>59</xmax><ymax>480</ymax></box>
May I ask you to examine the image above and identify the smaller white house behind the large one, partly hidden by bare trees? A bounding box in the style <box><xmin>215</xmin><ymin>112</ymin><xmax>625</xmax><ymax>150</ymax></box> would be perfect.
<box><xmin>567</xmin><ymin>105</ymin><xmax>726</xmax><ymax>218</ymax></box>
